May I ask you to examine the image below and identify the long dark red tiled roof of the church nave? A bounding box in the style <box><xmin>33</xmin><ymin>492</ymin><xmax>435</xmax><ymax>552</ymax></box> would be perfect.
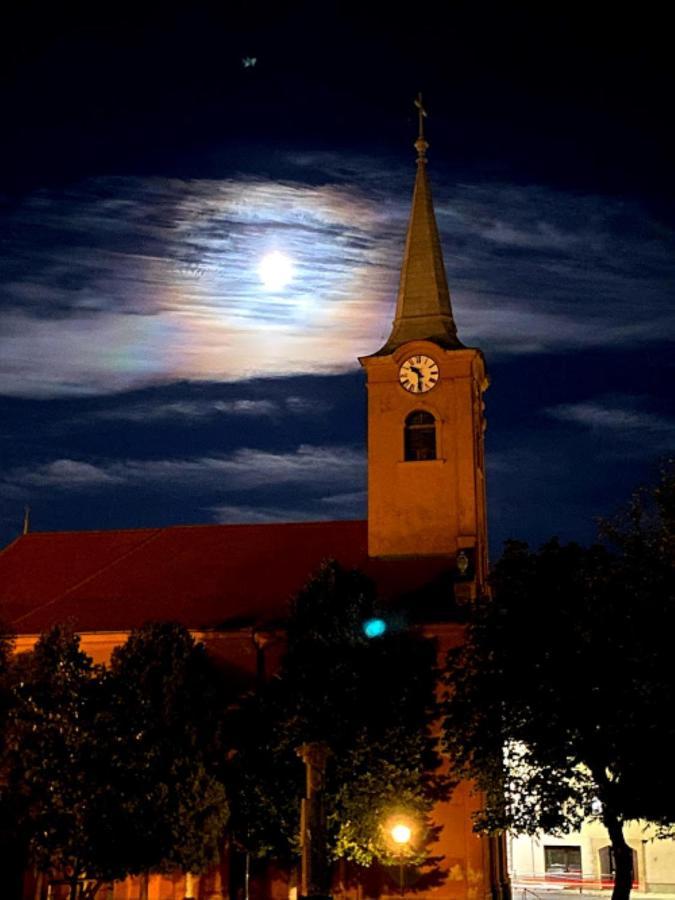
<box><xmin>0</xmin><ymin>521</ymin><xmax>456</xmax><ymax>634</ymax></box>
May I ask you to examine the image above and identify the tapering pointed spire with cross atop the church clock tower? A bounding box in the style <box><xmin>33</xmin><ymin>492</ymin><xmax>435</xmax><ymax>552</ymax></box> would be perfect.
<box><xmin>378</xmin><ymin>94</ymin><xmax>463</xmax><ymax>355</ymax></box>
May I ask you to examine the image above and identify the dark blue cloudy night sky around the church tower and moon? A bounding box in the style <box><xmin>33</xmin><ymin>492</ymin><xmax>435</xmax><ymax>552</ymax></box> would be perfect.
<box><xmin>0</xmin><ymin>2</ymin><xmax>675</xmax><ymax>556</ymax></box>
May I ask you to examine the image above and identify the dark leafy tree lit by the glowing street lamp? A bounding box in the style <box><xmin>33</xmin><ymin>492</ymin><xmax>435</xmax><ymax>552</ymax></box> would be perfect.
<box><xmin>230</xmin><ymin>562</ymin><xmax>447</xmax><ymax>888</ymax></box>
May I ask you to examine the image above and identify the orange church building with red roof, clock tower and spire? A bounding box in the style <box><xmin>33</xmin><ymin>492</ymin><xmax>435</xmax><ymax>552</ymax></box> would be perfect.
<box><xmin>0</xmin><ymin>115</ymin><xmax>507</xmax><ymax>900</ymax></box>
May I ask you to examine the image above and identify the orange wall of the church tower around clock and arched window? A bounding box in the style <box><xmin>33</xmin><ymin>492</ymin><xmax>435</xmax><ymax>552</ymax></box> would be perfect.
<box><xmin>361</xmin><ymin>341</ymin><xmax>487</xmax><ymax>574</ymax></box>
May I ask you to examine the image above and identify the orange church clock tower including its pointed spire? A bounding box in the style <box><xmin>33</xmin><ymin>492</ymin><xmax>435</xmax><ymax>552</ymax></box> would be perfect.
<box><xmin>360</xmin><ymin>100</ymin><xmax>488</xmax><ymax>588</ymax></box>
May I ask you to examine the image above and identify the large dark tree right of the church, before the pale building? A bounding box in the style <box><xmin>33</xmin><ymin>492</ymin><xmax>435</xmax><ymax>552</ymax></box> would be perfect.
<box><xmin>443</xmin><ymin>470</ymin><xmax>675</xmax><ymax>900</ymax></box>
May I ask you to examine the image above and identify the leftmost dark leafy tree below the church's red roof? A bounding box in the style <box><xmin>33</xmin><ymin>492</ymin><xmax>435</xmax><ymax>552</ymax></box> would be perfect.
<box><xmin>3</xmin><ymin>627</ymin><xmax>117</xmax><ymax>898</ymax></box>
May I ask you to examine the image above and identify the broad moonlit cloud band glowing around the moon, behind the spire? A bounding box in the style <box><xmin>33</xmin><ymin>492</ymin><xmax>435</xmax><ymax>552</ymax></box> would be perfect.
<box><xmin>0</xmin><ymin>164</ymin><xmax>675</xmax><ymax>394</ymax></box>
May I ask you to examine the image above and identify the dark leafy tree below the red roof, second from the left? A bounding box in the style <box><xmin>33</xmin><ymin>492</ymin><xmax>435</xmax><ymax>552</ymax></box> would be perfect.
<box><xmin>99</xmin><ymin>623</ymin><xmax>228</xmax><ymax>873</ymax></box>
